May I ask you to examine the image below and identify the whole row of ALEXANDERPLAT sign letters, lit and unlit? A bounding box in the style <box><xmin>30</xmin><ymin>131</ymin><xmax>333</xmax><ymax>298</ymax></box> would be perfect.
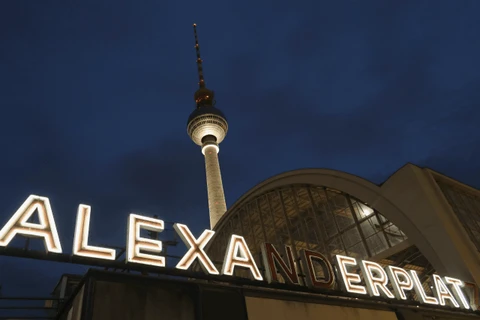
<box><xmin>0</xmin><ymin>195</ymin><xmax>477</xmax><ymax>309</ymax></box>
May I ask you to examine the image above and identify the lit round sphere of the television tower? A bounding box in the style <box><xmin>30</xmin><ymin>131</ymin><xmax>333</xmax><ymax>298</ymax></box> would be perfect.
<box><xmin>187</xmin><ymin>106</ymin><xmax>228</xmax><ymax>146</ymax></box>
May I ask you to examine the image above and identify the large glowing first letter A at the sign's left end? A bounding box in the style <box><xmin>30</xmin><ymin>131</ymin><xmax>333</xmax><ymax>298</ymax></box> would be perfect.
<box><xmin>0</xmin><ymin>195</ymin><xmax>62</xmax><ymax>253</ymax></box>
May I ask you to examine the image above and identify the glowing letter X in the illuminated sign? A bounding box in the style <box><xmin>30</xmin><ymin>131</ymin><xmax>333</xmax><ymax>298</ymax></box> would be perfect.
<box><xmin>173</xmin><ymin>223</ymin><xmax>219</xmax><ymax>275</ymax></box>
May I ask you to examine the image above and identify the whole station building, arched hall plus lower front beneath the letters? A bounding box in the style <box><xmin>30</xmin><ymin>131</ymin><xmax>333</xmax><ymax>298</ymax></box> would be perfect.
<box><xmin>50</xmin><ymin>164</ymin><xmax>480</xmax><ymax>320</ymax></box>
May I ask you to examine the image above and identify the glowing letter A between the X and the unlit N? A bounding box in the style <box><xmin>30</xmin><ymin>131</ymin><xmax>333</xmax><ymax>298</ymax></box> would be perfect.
<box><xmin>222</xmin><ymin>234</ymin><xmax>263</xmax><ymax>281</ymax></box>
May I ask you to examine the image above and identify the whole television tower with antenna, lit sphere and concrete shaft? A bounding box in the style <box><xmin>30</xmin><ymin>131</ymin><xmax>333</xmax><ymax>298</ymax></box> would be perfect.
<box><xmin>187</xmin><ymin>24</ymin><xmax>228</xmax><ymax>229</ymax></box>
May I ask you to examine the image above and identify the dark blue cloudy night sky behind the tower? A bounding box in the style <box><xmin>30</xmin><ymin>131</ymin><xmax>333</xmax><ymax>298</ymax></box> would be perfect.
<box><xmin>0</xmin><ymin>0</ymin><xmax>480</xmax><ymax>302</ymax></box>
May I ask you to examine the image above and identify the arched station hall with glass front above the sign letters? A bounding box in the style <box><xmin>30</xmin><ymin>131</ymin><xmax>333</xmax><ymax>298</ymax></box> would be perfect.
<box><xmin>210</xmin><ymin>164</ymin><xmax>480</xmax><ymax>285</ymax></box>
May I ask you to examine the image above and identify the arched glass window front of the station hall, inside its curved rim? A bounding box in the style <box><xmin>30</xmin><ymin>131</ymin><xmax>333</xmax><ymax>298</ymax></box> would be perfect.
<box><xmin>209</xmin><ymin>184</ymin><xmax>407</xmax><ymax>276</ymax></box>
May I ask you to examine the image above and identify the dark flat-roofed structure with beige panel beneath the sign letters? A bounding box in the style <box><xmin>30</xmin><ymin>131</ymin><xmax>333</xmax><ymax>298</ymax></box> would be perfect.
<box><xmin>57</xmin><ymin>270</ymin><xmax>478</xmax><ymax>320</ymax></box>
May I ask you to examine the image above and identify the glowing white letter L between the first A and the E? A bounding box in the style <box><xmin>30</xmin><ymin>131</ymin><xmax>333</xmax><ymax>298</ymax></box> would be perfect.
<box><xmin>73</xmin><ymin>204</ymin><xmax>116</xmax><ymax>260</ymax></box>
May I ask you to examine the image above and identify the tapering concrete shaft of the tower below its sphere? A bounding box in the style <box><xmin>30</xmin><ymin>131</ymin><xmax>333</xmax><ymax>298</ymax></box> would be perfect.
<box><xmin>203</xmin><ymin>145</ymin><xmax>227</xmax><ymax>229</ymax></box>
